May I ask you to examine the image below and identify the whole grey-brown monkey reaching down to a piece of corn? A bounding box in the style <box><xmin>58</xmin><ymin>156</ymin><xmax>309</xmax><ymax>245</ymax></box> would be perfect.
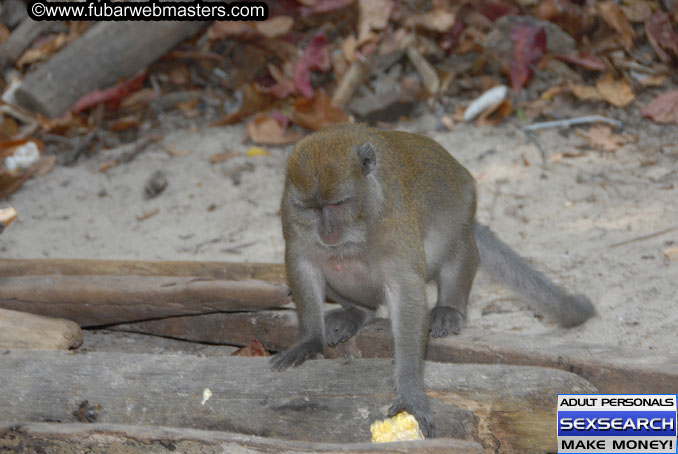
<box><xmin>271</xmin><ymin>124</ymin><xmax>596</xmax><ymax>437</ymax></box>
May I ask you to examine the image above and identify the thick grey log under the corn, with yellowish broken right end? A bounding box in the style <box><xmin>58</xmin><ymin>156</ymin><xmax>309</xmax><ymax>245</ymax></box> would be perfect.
<box><xmin>0</xmin><ymin>350</ymin><xmax>595</xmax><ymax>452</ymax></box>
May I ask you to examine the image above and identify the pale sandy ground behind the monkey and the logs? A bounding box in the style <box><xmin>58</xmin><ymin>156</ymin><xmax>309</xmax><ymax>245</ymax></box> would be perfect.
<box><xmin>0</xmin><ymin>119</ymin><xmax>678</xmax><ymax>354</ymax></box>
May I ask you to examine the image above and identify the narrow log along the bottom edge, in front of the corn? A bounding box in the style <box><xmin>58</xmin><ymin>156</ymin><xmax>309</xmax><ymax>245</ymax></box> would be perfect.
<box><xmin>0</xmin><ymin>423</ymin><xmax>483</xmax><ymax>454</ymax></box>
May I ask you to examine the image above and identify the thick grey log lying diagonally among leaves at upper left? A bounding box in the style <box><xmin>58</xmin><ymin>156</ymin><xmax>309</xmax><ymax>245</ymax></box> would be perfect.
<box><xmin>16</xmin><ymin>21</ymin><xmax>208</xmax><ymax>117</ymax></box>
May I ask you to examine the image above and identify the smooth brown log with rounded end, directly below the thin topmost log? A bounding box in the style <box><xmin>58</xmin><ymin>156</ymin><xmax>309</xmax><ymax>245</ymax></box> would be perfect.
<box><xmin>0</xmin><ymin>274</ymin><xmax>290</xmax><ymax>326</ymax></box>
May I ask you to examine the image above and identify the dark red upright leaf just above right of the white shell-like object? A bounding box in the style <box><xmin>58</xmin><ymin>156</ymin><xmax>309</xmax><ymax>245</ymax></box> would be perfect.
<box><xmin>510</xmin><ymin>22</ymin><xmax>546</xmax><ymax>93</ymax></box>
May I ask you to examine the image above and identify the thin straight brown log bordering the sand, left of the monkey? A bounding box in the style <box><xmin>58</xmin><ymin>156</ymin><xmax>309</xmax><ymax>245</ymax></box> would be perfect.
<box><xmin>0</xmin><ymin>259</ymin><xmax>286</xmax><ymax>284</ymax></box>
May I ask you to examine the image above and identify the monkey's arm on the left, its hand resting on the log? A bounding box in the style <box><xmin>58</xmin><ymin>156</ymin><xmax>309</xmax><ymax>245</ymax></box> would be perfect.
<box><xmin>271</xmin><ymin>252</ymin><xmax>325</xmax><ymax>370</ymax></box>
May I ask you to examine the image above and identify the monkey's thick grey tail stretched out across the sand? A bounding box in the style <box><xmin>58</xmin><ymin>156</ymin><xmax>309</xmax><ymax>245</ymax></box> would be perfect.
<box><xmin>473</xmin><ymin>222</ymin><xmax>596</xmax><ymax>327</ymax></box>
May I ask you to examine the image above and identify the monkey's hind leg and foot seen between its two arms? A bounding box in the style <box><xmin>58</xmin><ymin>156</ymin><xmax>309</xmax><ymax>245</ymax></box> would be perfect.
<box><xmin>325</xmin><ymin>288</ymin><xmax>375</xmax><ymax>347</ymax></box>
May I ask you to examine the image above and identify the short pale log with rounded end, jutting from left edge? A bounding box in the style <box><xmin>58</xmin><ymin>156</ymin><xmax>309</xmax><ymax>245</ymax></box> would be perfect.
<box><xmin>0</xmin><ymin>309</ymin><xmax>82</xmax><ymax>350</ymax></box>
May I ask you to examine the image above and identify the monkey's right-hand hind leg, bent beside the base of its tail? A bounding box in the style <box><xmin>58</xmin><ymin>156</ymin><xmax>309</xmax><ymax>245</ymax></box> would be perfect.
<box><xmin>429</xmin><ymin>232</ymin><xmax>478</xmax><ymax>337</ymax></box>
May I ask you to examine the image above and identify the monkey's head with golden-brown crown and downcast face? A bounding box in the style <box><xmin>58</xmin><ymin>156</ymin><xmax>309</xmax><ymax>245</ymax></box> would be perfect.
<box><xmin>282</xmin><ymin>126</ymin><xmax>377</xmax><ymax>254</ymax></box>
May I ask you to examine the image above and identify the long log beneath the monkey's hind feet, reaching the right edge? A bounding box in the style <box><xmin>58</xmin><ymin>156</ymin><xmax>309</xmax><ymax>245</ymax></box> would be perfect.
<box><xmin>112</xmin><ymin>310</ymin><xmax>678</xmax><ymax>393</ymax></box>
